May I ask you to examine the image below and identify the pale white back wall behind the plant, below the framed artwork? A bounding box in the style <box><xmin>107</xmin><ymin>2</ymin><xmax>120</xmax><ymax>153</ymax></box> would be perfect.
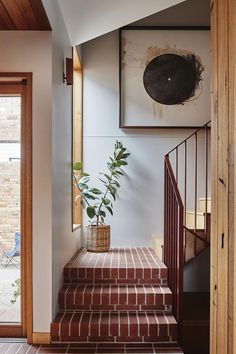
<box><xmin>82</xmin><ymin>31</ymin><xmax>208</xmax><ymax>246</ymax></box>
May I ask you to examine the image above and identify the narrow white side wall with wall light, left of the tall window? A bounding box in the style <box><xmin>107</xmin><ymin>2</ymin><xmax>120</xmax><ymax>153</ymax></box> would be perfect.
<box><xmin>43</xmin><ymin>0</ymin><xmax>80</xmax><ymax>317</ymax></box>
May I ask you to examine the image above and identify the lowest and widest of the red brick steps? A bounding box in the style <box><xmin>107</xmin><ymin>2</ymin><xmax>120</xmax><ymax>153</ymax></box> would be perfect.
<box><xmin>51</xmin><ymin>311</ymin><xmax>177</xmax><ymax>343</ymax></box>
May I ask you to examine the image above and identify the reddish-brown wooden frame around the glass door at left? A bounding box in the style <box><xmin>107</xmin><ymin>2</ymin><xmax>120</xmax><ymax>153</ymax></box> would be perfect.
<box><xmin>0</xmin><ymin>72</ymin><xmax>33</xmax><ymax>343</ymax></box>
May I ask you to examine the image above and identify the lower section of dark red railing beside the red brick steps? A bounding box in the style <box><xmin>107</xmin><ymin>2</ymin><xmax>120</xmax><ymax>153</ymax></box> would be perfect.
<box><xmin>164</xmin><ymin>156</ymin><xmax>184</xmax><ymax>342</ymax></box>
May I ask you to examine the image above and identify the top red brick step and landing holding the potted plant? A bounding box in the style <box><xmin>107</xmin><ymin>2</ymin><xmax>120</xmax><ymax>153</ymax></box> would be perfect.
<box><xmin>64</xmin><ymin>247</ymin><xmax>167</xmax><ymax>285</ymax></box>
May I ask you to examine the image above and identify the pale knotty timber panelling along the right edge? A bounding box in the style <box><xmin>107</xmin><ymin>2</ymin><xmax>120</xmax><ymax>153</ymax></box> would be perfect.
<box><xmin>210</xmin><ymin>0</ymin><xmax>236</xmax><ymax>354</ymax></box>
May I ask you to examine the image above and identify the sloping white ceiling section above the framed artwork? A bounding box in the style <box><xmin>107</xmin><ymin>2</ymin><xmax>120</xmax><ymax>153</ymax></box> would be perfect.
<box><xmin>58</xmin><ymin>0</ymin><xmax>184</xmax><ymax>45</ymax></box>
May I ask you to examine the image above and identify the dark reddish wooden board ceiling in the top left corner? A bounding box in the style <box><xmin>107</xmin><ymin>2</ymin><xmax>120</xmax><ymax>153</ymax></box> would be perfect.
<box><xmin>0</xmin><ymin>0</ymin><xmax>51</xmax><ymax>31</ymax></box>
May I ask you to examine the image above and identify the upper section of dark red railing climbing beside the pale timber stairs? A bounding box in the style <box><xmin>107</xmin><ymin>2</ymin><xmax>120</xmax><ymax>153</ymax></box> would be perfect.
<box><xmin>165</xmin><ymin>121</ymin><xmax>211</xmax><ymax>261</ymax></box>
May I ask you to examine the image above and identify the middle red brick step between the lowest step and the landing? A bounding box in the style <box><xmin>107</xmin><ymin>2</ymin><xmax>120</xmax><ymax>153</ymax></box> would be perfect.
<box><xmin>59</xmin><ymin>284</ymin><xmax>172</xmax><ymax>311</ymax></box>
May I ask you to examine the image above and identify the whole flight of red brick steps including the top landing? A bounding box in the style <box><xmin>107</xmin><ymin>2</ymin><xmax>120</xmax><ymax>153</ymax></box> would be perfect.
<box><xmin>51</xmin><ymin>247</ymin><xmax>183</xmax><ymax>353</ymax></box>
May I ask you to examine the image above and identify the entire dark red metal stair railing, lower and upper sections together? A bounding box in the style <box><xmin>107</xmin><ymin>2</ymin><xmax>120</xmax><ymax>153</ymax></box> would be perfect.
<box><xmin>164</xmin><ymin>122</ymin><xmax>211</xmax><ymax>342</ymax></box>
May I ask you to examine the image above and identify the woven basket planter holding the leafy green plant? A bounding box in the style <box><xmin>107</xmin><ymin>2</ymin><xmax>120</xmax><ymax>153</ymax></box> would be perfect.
<box><xmin>87</xmin><ymin>225</ymin><xmax>110</xmax><ymax>252</ymax></box>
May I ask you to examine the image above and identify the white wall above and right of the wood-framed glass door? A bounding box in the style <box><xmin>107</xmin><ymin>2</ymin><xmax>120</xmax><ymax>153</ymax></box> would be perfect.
<box><xmin>0</xmin><ymin>31</ymin><xmax>52</xmax><ymax>332</ymax></box>
